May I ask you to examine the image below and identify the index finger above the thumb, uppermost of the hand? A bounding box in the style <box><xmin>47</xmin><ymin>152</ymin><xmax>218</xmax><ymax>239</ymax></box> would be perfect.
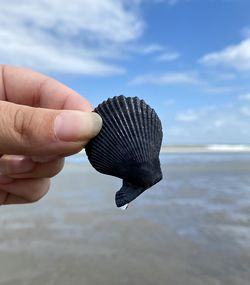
<box><xmin>0</xmin><ymin>65</ymin><xmax>92</xmax><ymax>112</ymax></box>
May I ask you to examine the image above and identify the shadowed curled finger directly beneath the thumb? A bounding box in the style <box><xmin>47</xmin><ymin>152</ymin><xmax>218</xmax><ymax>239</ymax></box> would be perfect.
<box><xmin>0</xmin><ymin>155</ymin><xmax>64</xmax><ymax>179</ymax></box>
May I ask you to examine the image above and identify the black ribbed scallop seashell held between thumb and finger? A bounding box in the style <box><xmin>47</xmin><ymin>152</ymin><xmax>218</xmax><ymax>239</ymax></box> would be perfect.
<box><xmin>86</xmin><ymin>95</ymin><xmax>162</xmax><ymax>207</ymax></box>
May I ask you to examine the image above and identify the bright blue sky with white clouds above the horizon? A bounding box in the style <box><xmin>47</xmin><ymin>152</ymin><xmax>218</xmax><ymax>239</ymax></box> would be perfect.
<box><xmin>0</xmin><ymin>0</ymin><xmax>250</xmax><ymax>144</ymax></box>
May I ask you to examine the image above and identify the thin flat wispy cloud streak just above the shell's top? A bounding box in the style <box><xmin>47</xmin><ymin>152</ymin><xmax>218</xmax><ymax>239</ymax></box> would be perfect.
<box><xmin>130</xmin><ymin>72</ymin><xmax>200</xmax><ymax>85</ymax></box>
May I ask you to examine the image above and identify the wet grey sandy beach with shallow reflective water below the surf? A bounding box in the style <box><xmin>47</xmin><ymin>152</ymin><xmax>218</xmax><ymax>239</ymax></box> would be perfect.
<box><xmin>0</xmin><ymin>150</ymin><xmax>250</xmax><ymax>285</ymax></box>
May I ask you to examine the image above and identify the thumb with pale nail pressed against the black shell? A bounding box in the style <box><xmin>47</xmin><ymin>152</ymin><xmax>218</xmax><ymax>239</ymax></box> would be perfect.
<box><xmin>0</xmin><ymin>101</ymin><xmax>102</xmax><ymax>156</ymax></box>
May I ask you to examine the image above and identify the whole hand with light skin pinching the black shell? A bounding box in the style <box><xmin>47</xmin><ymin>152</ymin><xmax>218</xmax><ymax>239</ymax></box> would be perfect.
<box><xmin>0</xmin><ymin>65</ymin><xmax>101</xmax><ymax>205</ymax></box>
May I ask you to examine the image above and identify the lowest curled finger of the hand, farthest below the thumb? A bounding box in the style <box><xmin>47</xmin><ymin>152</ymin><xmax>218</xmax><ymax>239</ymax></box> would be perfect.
<box><xmin>0</xmin><ymin>178</ymin><xmax>50</xmax><ymax>205</ymax></box>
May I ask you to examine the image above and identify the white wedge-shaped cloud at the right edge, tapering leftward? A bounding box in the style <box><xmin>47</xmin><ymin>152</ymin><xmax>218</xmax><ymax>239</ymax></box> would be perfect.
<box><xmin>200</xmin><ymin>38</ymin><xmax>250</xmax><ymax>71</ymax></box>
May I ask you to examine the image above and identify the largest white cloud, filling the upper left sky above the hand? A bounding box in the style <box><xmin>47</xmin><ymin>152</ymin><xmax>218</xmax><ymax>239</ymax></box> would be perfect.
<box><xmin>0</xmin><ymin>0</ymin><xmax>144</xmax><ymax>75</ymax></box>
